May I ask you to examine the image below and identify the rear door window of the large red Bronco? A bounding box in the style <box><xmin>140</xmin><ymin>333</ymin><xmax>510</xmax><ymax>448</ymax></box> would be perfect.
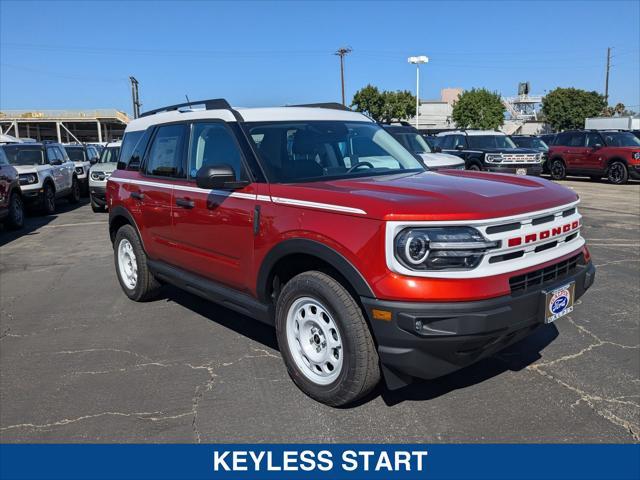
<box><xmin>145</xmin><ymin>125</ymin><xmax>187</xmax><ymax>178</ymax></box>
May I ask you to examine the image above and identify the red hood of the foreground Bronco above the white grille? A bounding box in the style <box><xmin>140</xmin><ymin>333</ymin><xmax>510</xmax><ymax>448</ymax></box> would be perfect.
<box><xmin>270</xmin><ymin>170</ymin><xmax>578</xmax><ymax>221</ymax></box>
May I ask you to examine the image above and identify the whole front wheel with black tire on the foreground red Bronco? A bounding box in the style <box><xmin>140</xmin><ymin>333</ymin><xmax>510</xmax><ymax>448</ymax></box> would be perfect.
<box><xmin>276</xmin><ymin>271</ymin><xmax>380</xmax><ymax>407</ymax></box>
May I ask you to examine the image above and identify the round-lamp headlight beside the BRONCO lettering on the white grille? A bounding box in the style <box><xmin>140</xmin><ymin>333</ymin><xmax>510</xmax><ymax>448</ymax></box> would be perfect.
<box><xmin>395</xmin><ymin>227</ymin><xmax>499</xmax><ymax>271</ymax></box>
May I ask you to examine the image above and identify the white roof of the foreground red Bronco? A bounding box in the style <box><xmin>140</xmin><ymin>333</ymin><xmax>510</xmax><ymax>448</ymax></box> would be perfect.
<box><xmin>127</xmin><ymin>107</ymin><xmax>373</xmax><ymax>132</ymax></box>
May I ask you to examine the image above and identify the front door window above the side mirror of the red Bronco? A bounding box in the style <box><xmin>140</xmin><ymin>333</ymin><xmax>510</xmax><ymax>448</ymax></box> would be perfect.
<box><xmin>189</xmin><ymin>122</ymin><xmax>242</xmax><ymax>180</ymax></box>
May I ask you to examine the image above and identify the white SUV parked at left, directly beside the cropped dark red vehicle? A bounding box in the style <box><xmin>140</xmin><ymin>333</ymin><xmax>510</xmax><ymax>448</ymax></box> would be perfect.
<box><xmin>1</xmin><ymin>142</ymin><xmax>80</xmax><ymax>215</ymax></box>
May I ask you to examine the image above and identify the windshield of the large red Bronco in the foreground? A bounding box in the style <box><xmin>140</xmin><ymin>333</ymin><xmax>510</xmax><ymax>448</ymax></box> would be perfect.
<box><xmin>244</xmin><ymin>121</ymin><xmax>425</xmax><ymax>183</ymax></box>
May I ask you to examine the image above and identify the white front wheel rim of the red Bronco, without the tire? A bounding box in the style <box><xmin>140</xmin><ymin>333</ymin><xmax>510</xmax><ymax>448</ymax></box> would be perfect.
<box><xmin>287</xmin><ymin>297</ymin><xmax>344</xmax><ymax>385</ymax></box>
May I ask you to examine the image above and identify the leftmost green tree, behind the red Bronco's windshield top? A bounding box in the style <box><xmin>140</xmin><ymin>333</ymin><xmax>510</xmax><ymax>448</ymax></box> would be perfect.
<box><xmin>351</xmin><ymin>85</ymin><xmax>416</xmax><ymax>122</ymax></box>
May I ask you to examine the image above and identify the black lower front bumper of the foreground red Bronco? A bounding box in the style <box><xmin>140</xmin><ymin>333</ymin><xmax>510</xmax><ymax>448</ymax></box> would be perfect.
<box><xmin>361</xmin><ymin>261</ymin><xmax>595</xmax><ymax>389</ymax></box>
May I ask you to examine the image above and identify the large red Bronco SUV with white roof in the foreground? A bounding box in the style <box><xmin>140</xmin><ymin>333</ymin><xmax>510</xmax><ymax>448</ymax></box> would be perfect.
<box><xmin>106</xmin><ymin>100</ymin><xmax>595</xmax><ymax>406</ymax></box>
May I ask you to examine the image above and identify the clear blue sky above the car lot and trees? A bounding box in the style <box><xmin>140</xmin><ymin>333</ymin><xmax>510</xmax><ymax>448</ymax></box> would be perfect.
<box><xmin>0</xmin><ymin>0</ymin><xmax>640</xmax><ymax>113</ymax></box>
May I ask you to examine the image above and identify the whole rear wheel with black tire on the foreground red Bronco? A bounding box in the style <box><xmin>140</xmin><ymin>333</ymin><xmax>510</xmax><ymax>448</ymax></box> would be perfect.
<box><xmin>113</xmin><ymin>225</ymin><xmax>160</xmax><ymax>302</ymax></box>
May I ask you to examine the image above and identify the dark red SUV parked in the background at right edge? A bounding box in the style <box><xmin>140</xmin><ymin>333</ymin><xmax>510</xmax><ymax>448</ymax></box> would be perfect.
<box><xmin>549</xmin><ymin>130</ymin><xmax>640</xmax><ymax>184</ymax></box>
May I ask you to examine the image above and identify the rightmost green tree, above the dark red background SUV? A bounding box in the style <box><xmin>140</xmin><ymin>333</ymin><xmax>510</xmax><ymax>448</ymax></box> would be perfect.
<box><xmin>542</xmin><ymin>88</ymin><xmax>607</xmax><ymax>130</ymax></box>
